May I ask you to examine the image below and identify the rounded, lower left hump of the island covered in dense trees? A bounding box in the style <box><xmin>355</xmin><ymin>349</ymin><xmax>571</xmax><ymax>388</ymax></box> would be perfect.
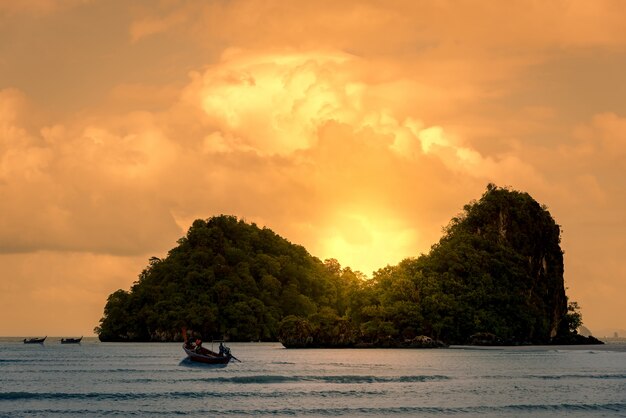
<box><xmin>96</xmin><ymin>216</ymin><xmax>357</xmax><ymax>341</ymax></box>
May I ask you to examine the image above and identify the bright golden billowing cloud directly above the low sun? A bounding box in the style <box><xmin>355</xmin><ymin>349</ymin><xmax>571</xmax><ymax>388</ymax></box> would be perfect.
<box><xmin>169</xmin><ymin>51</ymin><xmax>502</xmax><ymax>272</ymax></box>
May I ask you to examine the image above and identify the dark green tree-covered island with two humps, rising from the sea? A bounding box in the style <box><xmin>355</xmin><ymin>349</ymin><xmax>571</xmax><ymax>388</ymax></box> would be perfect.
<box><xmin>95</xmin><ymin>184</ymin><xmax>597</xmax><ymax>347</ymax></box>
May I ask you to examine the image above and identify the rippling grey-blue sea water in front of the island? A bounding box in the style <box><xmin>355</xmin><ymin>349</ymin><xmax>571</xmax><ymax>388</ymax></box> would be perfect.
<box><xmin>0</xmin><ymin>338</ymin><xmax>626</xmax><ymax>417</ymax></box>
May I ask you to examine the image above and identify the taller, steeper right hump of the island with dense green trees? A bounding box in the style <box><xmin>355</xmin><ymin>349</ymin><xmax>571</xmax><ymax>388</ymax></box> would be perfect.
<box><xmin>344</xmin><ymin>185</ymin><xmax>568</xmax><ymax>343</ymax></box>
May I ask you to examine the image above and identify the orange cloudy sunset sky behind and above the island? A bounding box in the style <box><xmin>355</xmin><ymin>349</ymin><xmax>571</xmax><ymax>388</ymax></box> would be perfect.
<box><xmin>0</xmin><ymin>0</ymin><xmax>626</xmax><ymax>336</ymax></box>
